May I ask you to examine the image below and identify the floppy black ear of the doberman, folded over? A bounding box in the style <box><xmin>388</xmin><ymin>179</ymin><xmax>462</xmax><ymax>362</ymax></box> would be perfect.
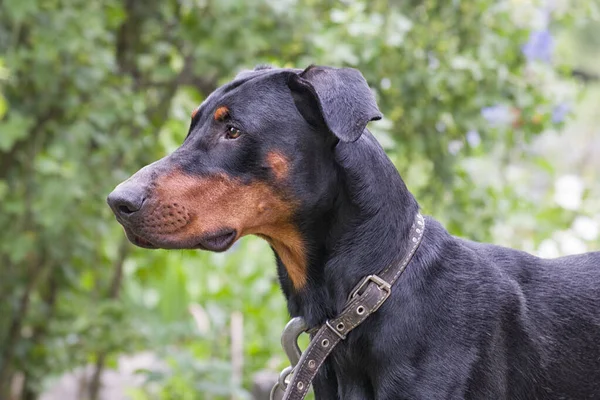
<box><xmin>288</xmin><ymin>66</ymin><xmax>382</xmax><ymax>142</ymax></box>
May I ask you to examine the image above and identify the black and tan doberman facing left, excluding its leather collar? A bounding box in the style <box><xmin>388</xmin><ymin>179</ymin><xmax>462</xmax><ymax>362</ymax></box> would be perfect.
<box><xmin>108</xmin><ymin>66</ymin><xmax>600</xmax><ymax>400</ymax></box>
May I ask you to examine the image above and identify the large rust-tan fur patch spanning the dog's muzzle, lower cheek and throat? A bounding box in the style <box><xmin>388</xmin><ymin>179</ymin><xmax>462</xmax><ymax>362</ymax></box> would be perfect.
<box><xmin>146</xmin><ymin>171</ymin><xmax>307</xmax><ymax>289</ymax></box>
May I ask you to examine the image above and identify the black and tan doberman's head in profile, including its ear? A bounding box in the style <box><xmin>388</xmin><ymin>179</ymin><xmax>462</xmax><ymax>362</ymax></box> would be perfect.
<box><xmin>108</xmin><ymin>66</ymin><xmax>381</xmax><ymax>285</ymax></box>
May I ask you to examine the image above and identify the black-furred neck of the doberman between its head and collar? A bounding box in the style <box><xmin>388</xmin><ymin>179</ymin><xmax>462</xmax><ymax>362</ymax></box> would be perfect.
<box><xmin>278</xmin><ymin>131</ymin><xmax>418</xmax><ymax>327</ymax></box>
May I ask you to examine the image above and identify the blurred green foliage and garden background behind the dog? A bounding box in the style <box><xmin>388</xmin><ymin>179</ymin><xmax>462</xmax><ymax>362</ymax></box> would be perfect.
<box><xmin>0</xmin><ymin>0</ymin><xmax>600</xmax><ymax>400</ymax></box>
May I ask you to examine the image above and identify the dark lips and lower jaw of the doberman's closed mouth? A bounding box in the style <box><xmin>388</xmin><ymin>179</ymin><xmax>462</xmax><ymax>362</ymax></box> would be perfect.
<box><xmin>120</xmin><ymin>227</ymin><xmax>238</xmax><ymax>252</ymax></box>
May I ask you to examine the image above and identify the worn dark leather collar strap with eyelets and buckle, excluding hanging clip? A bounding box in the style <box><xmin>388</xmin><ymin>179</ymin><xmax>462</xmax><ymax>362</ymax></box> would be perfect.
<box><xmin>283</xmin><ymin>213</ymin><xmax>425</xmax><ymax>400</ymax></box>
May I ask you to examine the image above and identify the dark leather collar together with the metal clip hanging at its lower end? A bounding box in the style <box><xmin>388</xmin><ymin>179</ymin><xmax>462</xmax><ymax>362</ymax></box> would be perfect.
<box><xmin>271</xmin><ymin>213</ymin><xmax>425</xmax><ymax>400</ymax></box>
